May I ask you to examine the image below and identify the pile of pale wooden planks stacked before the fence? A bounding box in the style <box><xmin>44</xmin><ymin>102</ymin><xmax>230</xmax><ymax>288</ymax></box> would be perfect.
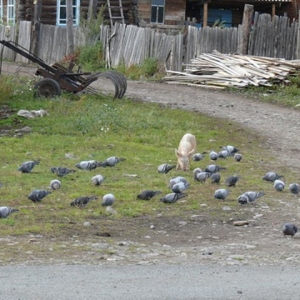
<box><xmin>164</xmin><ymin>51</ymin><xmax>300</xmax><ymax>88</ymax></box>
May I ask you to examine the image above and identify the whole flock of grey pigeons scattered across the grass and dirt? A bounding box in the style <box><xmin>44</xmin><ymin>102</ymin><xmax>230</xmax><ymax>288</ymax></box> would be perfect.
<box><xmin>0</xmin><ymin>145</ymin><xmax>300</xmax><ymax>236</ymax></box>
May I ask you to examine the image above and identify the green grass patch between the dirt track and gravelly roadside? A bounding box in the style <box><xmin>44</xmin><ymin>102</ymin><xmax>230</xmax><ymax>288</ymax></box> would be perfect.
<box><xmin>0</xmin><ymin>73</ymin><xmax>293</xmax><ymax>236</ymax></box>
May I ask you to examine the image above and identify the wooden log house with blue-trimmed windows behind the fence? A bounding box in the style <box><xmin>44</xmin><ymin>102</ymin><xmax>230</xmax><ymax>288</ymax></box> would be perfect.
<box><xmin>0</xmin><ymin>0</ymin><xmax>300</xmax><ymax>29</ymax></box>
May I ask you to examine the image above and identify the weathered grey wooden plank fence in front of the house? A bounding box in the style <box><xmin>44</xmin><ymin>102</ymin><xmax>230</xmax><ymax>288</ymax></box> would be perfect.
<box><xmin>0</xmin><ymin>13</ymin><xmax>300</xmax><ymax>71</ymax></box>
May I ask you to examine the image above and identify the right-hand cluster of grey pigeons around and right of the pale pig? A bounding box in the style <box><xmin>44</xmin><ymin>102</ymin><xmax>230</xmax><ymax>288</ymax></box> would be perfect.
<box><xmin>151</xmin><ymin>145</ymin><xmax>300</xmax><ymax>236</ymax></box>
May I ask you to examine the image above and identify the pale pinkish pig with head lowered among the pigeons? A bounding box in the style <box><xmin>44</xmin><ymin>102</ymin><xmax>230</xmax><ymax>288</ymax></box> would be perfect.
<box><xmin>175</xmin><ymin>133</ymin><xmax>197</xmax><ymax>171</ymax></box>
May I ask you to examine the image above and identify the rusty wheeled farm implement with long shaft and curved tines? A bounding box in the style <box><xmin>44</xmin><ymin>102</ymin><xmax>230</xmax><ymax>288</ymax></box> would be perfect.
<box><xmin>0</xmin><ymin>40</ymin><xmax>127</xmax><ymax>99</ymax></box>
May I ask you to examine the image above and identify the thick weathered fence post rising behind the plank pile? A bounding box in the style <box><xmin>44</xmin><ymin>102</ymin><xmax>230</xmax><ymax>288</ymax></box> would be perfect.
<box><xmin>237</xmin><ymin>4</ymin><xmax>254</xmax><ymax>54</ymax></box>
